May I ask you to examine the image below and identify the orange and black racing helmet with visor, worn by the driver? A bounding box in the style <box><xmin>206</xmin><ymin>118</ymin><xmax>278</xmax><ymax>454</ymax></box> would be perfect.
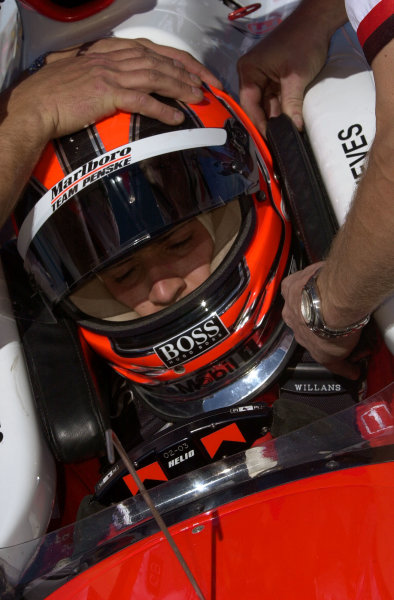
<box><xmin>15</xmin><ymin>88</ymin><xmax>294</xmax><ymax>419</ymax></box>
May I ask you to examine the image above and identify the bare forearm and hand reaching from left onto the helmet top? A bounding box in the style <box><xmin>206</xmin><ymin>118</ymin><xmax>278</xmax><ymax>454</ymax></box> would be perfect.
<box><xmin>0</xmin><ymin>38</ymin><xmax>221</xmax><ymax>226</ymax></box>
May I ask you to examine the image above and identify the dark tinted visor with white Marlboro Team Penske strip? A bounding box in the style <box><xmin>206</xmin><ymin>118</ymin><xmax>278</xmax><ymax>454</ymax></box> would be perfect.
<box><xmin>18</xmin><ymin>129</ymin><xmax>259</xmax><ymax>302</ymax></box>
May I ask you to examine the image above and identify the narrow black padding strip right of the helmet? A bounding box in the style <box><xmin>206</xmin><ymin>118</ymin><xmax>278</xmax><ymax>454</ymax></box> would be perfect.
<box><xmin>267</xmin><ymin>114</ymin><xmax>338</xmax><ymax>263</ymax></box>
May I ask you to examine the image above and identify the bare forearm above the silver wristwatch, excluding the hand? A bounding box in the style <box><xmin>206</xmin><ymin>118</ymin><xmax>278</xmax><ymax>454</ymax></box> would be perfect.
<box><xmin>318</xmin><ymin>139</ymin><xmax>394</xmax><ymax>327</ymax></box>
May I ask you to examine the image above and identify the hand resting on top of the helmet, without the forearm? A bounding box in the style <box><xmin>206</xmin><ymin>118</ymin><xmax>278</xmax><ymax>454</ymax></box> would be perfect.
<box><xmin>7</xmin><ymin>38</ymin><xmax>222</xmax><ymax>140</ymax></box>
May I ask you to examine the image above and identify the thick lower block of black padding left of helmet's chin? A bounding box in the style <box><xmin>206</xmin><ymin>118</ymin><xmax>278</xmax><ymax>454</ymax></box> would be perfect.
<box><xmin>23</xmin><ymin>319</ymin><xmax>106</xmax><ymax>462</ymax></box>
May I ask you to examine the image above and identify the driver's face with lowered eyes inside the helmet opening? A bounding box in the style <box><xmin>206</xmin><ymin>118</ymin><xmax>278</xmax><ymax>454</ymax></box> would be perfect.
<box><xmin>101</xmin><ymin>219</ymin><xmax>213</xmax><ymax>317</ymax></box>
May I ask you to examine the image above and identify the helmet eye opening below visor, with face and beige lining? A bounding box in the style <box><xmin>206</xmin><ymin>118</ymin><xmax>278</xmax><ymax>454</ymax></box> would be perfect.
<box><xmin>70</xmin><ymin>202</ymin><xmax>242</xmax><ymax>321</ymax></box>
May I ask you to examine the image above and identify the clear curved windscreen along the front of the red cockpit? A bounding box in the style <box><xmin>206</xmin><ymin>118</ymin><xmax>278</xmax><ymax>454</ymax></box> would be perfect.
<box><xmin>0</xmin><ymin>384</ymin><xmax>394</xmax><ymax>599</ymax></box>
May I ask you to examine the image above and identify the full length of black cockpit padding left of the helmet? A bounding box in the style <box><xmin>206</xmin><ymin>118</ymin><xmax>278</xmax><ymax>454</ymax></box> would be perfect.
<box><xmin>2</xmin><ymin>248</ymin><xmax>109</xmax><ymax>463</ymax></box>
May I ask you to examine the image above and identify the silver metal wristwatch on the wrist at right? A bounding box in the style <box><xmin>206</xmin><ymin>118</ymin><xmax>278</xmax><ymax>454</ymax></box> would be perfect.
<box><xmin>301</xmin><ymin>269</ymin><xmax>370</xmax><ymax>338</ymax></box>
